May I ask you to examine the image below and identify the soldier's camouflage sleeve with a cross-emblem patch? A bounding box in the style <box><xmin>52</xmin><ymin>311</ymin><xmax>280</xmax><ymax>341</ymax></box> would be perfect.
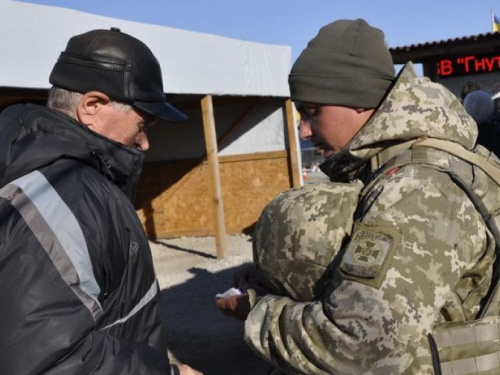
<box><xmin>245</xmin><ymin>166</ymin><xmax>492</xmax><ymax>374</ymax></box>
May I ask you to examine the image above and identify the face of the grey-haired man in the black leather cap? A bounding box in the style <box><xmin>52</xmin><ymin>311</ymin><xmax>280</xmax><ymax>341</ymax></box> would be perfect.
<box><xmin>90</xmin><ymin>103</ymin><xmax>149</xmax><ymax>151</ymax></box>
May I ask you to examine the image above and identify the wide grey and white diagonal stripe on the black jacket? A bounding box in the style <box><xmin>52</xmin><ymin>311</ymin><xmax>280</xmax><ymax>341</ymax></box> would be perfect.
<box><xmin>0</xmin><ymin>171</ymin><xmax>102</xmax><ymax>320</ymax></box>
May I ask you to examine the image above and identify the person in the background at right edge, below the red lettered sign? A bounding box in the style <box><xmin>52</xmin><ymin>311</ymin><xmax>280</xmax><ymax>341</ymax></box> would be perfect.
<box><xmin>463</xmin><ymin>90</ymin><xmax>500</xmax><ymax>156</ymax></box>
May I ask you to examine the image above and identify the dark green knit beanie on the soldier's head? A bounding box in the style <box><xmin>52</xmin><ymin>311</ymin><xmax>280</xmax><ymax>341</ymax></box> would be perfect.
<box><xmin>288</xmin><ymin>19</ymin><xmax>395</xmax><ymax>109</ymax></box>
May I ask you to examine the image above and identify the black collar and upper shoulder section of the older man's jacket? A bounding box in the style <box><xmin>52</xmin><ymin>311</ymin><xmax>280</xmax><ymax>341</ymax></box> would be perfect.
<box><xmin>0</xmin><ymin>104</ymin><xmax>144</xmax><ymax>200</ymax></box>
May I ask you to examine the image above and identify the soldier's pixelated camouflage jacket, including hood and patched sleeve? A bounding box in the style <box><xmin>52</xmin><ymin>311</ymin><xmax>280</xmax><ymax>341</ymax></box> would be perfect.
<box><xmin>245</xmin><ymin>63</ymin><xmax>495</xmax><ymax>375</ymax></box>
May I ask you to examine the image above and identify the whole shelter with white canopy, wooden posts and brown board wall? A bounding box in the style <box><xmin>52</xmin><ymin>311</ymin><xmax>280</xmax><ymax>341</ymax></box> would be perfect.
<box><xmin>0</xmin><ymin>0</ymin><xmax>300</xmax><ymax>256</ymax></box>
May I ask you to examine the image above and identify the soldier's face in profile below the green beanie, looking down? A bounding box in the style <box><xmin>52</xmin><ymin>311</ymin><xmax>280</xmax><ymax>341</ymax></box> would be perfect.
<box><xmin>295</xmin><ymin>102</ymin><xmax>373</xmax><ymax>158</ymax></box>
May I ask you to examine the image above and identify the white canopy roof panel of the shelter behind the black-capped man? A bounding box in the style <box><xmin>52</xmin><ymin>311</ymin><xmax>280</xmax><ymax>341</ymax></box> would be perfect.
<box><xmin>0</xmin><ymin>0</ymin><xmax>291</xmax><ymax>97</ymax></box>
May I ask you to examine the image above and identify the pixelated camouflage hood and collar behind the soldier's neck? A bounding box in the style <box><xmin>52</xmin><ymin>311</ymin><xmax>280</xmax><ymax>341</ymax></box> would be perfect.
<box><xmin>320</xmin><ymin>62</ymin><xmax>477</xmax><ymax>181</ymax></box>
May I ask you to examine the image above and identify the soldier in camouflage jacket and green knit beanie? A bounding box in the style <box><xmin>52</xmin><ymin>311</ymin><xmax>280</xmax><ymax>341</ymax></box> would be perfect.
<box><xmin>218</xmin><ymin>19</ymin><xmax>499</xmax><ymax>374</ymax></box>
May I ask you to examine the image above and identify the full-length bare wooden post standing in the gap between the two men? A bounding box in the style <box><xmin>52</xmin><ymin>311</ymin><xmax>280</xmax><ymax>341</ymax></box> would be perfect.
<box><xmin>201</xmin><ymin>95</ymin><xmax>227</xmax><ymax>259</ymax></box>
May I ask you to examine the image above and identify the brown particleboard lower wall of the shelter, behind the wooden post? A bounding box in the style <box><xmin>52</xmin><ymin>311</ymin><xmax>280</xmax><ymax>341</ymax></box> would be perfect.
<box><xmin>136</xmin><ymin>150</ymin><xmax>292</xmax><ymax>238</ymax></box>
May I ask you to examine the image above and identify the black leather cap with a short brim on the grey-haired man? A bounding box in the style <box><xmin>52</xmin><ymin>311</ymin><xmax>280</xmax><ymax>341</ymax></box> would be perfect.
<box><xmin>49</xmin><ymin>28</ymin><xmax>187</xmax><ymax>122</ymax></box>
